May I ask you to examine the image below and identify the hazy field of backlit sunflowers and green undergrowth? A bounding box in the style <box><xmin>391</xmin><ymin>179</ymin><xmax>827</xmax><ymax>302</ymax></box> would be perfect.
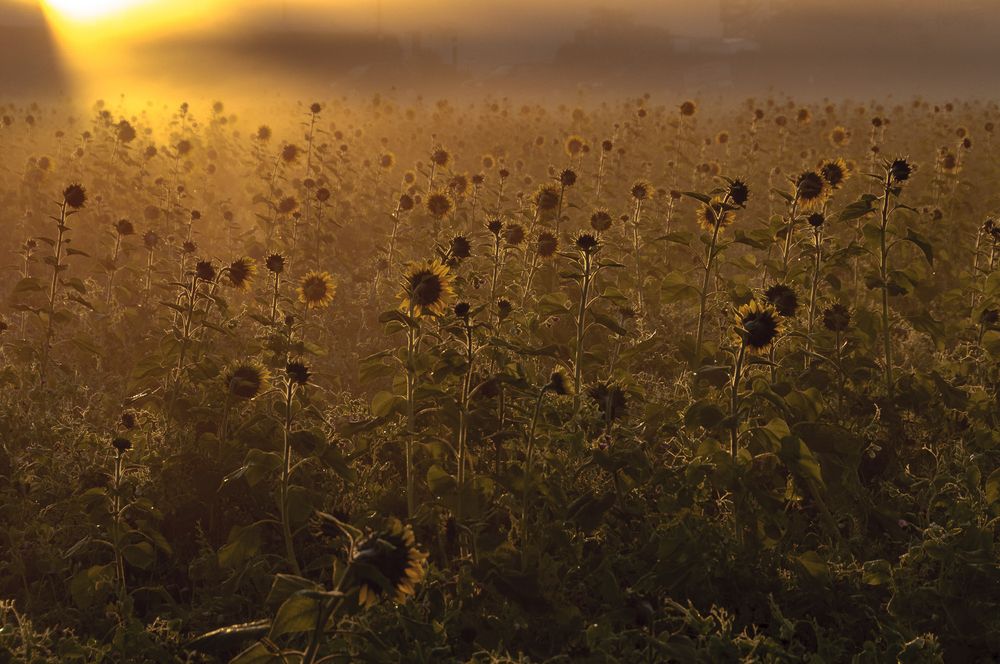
<box><xmin>0</xmin><ymin>93</ymin><xmax>1000</xmax><ymax>664</ymax></box>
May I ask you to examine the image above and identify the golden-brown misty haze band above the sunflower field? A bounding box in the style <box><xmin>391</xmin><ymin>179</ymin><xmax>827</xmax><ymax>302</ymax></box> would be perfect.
<box><xmin>0</xmin><ymin>0</ymin><xmax>1000</xmax><ymax>99</ymax></box>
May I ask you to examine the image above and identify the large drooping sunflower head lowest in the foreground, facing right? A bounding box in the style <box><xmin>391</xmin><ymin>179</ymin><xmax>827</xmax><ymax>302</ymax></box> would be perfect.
<box><xmin>351</xmin><ymin>519</ymin><xmax>427</xmax><ymax>608</ymax></box>
